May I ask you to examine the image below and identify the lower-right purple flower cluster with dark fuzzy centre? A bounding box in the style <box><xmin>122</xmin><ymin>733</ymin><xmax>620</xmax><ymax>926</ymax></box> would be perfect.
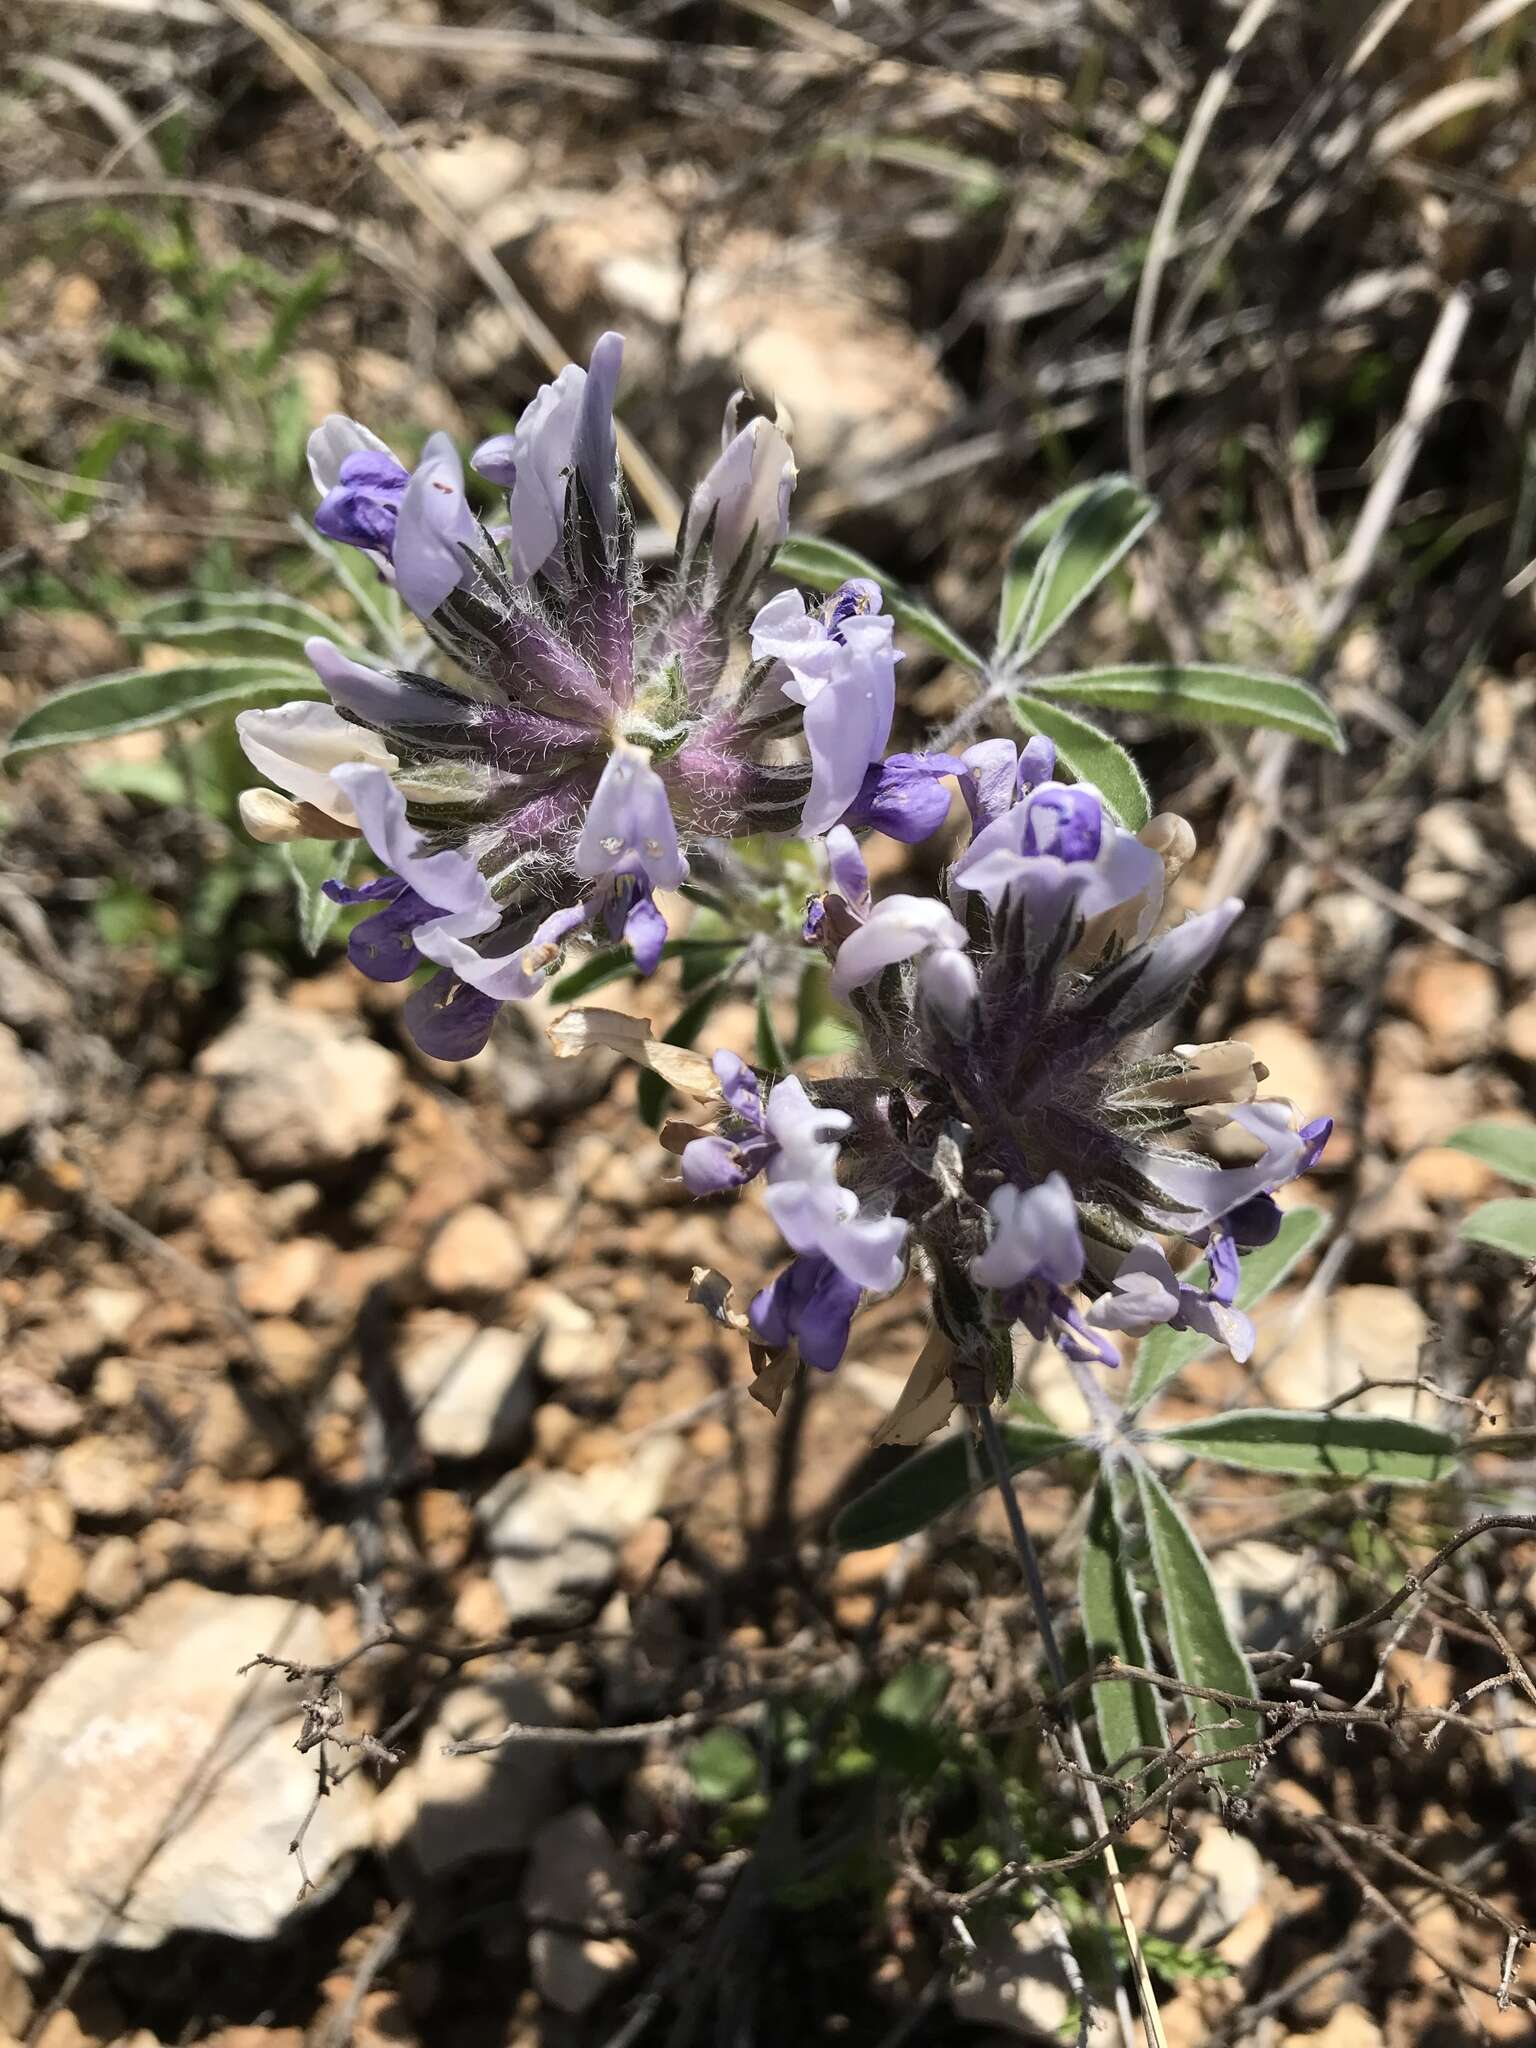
<box><xmin>682</xmin><ymin>739</ymin><xmax>1331</xmax><ymax>1366</ymax></box>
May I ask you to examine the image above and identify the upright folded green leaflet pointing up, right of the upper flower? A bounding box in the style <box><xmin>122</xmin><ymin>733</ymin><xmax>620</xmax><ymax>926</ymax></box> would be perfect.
<box><xmin>997</xmin><ymin>477</ymin><xmax>1157</xmax><ymax>664</ymax></box>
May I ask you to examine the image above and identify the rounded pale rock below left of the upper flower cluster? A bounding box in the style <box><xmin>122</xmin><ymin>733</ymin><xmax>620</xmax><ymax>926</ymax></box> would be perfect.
<box><xmin>195</xmin><ymin>997</ymin><xmax>403</xmax><ymax>1176</ymax></box>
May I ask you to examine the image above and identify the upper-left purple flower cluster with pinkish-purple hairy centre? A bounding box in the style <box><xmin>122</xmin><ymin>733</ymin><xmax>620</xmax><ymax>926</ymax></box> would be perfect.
<box><xmin>238</xmin><ymin>334</ymin><xmax>913</xmax><ymax>1059</ymax></box>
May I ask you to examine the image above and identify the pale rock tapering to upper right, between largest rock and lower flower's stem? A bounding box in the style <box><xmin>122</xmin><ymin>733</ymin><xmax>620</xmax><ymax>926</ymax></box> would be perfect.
<box><xmin>479</xmin><ymin>1436</ymin><xmax>680</xmax><ymax>1622</ymax></box>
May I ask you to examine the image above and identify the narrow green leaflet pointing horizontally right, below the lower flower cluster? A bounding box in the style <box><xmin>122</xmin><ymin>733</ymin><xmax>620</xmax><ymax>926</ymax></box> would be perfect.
<box><xmin>1155</xmin><ymin>1409</ymin><xmax>1458</xmax><ymax>1487</ymax></box>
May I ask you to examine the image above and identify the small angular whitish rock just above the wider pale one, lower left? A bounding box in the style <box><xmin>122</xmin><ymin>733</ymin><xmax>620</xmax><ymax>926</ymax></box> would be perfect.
<box><xmin>399</xmin><ymin>1309</ymin><xmax>535</xmax><ymax>1458</ymax></box>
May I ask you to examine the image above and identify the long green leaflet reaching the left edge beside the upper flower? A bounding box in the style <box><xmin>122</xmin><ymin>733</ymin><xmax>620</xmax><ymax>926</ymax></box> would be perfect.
<box><xmin>4</xmin><ymin>657</ymin><xmax>326</xmax><ymax>764</ymax></box>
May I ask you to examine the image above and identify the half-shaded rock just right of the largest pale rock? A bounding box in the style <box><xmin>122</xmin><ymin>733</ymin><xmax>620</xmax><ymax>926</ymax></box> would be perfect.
<box><xmin>377</xmin><ymin>1673</ymin><xmax>571</xmax><ymax>1878</ymax></box>
